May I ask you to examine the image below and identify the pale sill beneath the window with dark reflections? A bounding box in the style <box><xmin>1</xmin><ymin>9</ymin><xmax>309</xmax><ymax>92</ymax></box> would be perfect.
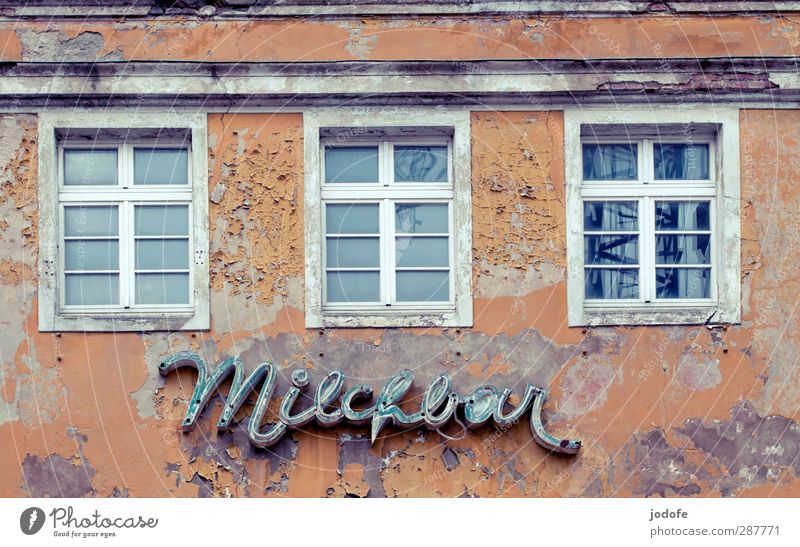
<box><xmin>569</xmin><ymin>305</ymin><xmax>741</xmax><ymax>327</ymax></box>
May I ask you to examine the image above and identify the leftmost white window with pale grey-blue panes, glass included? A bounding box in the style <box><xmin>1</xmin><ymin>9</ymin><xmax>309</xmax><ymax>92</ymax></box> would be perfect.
<box><xmin>41</xmin><ymin>112</ymin><xmax>208</xmax><ymax>330</ymax></box>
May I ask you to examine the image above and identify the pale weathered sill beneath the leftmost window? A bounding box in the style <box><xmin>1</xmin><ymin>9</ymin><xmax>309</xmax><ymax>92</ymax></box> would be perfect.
<box><xmin>39</xmin><ymin>311</ymin><xmax>210</xmax><ymax>332</ymax></box>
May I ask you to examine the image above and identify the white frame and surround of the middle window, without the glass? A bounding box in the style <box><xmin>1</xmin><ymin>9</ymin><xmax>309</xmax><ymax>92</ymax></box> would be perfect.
<box><xmin>304</xmin><ymin>108</ymin><xmax>472</xmax><ymax>328</ymax></box>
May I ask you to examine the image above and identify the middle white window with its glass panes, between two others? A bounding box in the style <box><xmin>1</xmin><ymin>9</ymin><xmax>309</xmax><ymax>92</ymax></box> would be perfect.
<box><xmin>307</xmin><ymin>109</ymin><xmax>471</xmax><ymax>326</ymax></box>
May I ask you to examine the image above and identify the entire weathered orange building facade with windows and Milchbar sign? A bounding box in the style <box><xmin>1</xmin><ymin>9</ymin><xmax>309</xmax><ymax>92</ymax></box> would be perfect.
<box><xmin>0</xmin><ymin>0</ymin><xmax>800</xmax><ymax>497</ymax></box>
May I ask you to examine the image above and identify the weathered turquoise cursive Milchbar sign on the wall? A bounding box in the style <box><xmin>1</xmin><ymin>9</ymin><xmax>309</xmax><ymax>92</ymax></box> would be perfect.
<box><xmin>159</xmin><ymin>352</ymin><xmax>581</xmax><ymax>454</ymax></box>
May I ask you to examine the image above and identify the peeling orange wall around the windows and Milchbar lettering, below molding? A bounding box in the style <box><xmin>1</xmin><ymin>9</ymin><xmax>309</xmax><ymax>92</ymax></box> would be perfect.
<box><xmin>0</xmin><ymin>105</ymin><xmax>800</xmax><ymax>496</ymax></box>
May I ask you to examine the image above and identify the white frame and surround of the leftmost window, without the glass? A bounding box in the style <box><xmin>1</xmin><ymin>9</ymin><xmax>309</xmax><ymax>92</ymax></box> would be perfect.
<box><xmin>39</xmin><ymin>110</ymin><xmax>210</xmax><ymax>331</ymax></box>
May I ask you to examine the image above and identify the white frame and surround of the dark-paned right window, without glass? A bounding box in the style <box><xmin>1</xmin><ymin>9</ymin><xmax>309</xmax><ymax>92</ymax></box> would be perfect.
<box><xmin>565</xmin><ymin>107</ymin><xmax>741</xmax><ymax>326</ymax></box>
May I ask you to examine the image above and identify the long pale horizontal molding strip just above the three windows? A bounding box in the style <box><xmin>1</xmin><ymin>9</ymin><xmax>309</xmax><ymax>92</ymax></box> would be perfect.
<box><xmin>0</xmin><ymin>57</ymin><xmax>800</xmax><ymax>106</ymax></box>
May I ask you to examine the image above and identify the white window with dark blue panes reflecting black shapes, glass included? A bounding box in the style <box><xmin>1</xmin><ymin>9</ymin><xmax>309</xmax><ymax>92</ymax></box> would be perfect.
<box><xmin>567</xmin><ymin>109</ymin><xmax>739</xmax><ymax>325</ymax></box>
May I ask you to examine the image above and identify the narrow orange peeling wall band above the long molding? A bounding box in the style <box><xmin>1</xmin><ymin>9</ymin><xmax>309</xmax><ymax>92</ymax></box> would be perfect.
<box><xmin>6</xmin><ymin>15</ymin><xmax>800</xmax><ymax>62</ymax></box>
